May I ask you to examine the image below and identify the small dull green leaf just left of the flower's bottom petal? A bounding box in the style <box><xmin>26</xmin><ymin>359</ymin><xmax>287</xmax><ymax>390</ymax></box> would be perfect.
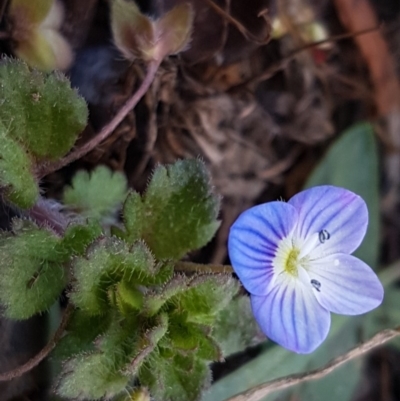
<box><xmin>213</xmin><ymin>296</ymin><xmax>260</xmax><ymax>356</ymax></box>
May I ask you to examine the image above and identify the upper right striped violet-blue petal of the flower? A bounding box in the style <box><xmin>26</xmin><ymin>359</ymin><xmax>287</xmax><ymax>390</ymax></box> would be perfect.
<box><xmin>289</xmin><ymin>185</ymin><xmax>368</xmax><ymax>258</ymax></box>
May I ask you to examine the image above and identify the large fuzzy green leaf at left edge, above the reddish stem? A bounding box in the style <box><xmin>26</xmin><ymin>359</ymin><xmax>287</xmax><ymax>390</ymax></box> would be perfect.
<box><xmin>0</xmin><ymin>59</ymin><xmax>88</xmax><ymax>161</ymax></box>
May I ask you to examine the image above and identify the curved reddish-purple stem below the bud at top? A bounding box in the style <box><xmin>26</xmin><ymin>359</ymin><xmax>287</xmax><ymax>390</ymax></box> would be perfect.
<box><xmin>37</xmin><ymin>61</ymin><xmax>160</xmax><ymax>178</ymax></box>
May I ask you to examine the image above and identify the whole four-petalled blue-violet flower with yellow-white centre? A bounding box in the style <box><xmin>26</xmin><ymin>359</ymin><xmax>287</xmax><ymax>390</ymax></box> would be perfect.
<box><xmin>228</xmin><ymin>186</ymin><xmax>383</xmax><ymax>353</ymax></box>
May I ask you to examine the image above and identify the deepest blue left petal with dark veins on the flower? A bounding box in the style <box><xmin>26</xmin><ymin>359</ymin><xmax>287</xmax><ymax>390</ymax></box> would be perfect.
<box><xmin>228</xmin><ymin>202</ymin><xmax>297</xmax><ymax>295</ymax></box>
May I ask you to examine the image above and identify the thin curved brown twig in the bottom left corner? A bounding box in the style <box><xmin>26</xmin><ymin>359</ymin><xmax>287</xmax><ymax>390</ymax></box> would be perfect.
<box><xmin>0</xmin><ymin>304</ymin><xmax>73</xmax><ymax>382</ymax></box>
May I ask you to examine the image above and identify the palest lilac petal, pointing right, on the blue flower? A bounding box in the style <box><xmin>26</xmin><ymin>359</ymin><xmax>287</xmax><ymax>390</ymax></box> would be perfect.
<box><xmin>308</xmin><ymin>254</ymin><xmax>383</xmax><ymax>315</ymax></box>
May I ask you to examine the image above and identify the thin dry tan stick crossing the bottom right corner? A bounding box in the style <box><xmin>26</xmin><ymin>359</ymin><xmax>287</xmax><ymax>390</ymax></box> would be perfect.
<box><xmin>225</xmin><ymin>327</ymin><xmax>400</xmax><ymax>401</ymax></box>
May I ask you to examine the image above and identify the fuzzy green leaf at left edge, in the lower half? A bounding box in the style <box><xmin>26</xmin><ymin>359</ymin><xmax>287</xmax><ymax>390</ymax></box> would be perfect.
<box><xmin>0</xmin><ymin>220</ymin><xmax>67</xmax><ymax>319</ymax></box>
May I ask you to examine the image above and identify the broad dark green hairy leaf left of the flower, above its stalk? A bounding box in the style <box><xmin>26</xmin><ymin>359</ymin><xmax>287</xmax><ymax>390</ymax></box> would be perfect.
<box><xmin>123</xmin><ymin>160</ymin><xmax>219</xmax><ymax>259</ymax></box>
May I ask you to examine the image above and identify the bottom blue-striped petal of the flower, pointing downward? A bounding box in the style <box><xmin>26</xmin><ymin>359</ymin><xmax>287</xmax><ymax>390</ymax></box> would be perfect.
<box><xmin>251</xmin><ymin>278</ymin><xmax>331</xmax><ymax>354</ymax></box>
